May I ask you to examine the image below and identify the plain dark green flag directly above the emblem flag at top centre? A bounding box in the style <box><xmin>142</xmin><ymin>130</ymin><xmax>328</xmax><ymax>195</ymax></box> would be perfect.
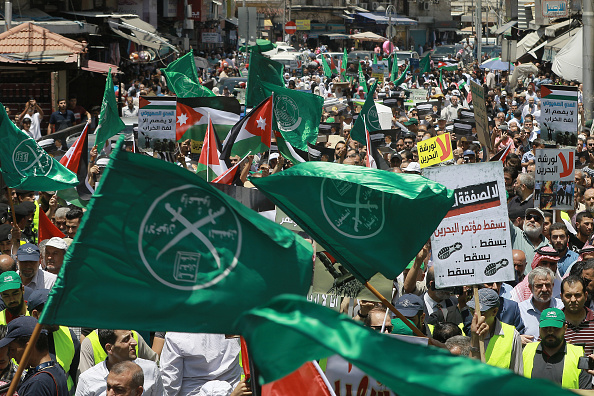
<box><xmin>245</xmin><ymin>51</ymin><xmax>285</xmax><ymax>107</ymax></box>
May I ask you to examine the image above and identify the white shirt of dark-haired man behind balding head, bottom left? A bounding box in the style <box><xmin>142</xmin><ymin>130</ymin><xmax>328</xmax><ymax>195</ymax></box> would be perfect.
<box><xmin>75</xmin><ymin>358</ymin><xmax>163</xmax><ymax>396</ymax></box>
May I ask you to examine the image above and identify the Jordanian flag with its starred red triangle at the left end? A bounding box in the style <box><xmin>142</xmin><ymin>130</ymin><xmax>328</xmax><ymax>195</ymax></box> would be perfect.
<box><xmin>175</xmin><ymin>96</ymin><xmax>241</xmax><ymax>141</ymax></box>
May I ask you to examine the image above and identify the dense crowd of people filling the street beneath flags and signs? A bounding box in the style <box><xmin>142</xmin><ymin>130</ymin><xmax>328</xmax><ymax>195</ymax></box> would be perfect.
<box><xmin>0</xmin><ymin>41</ymin><xmax>594</xmax><ymax>396</ymax></box>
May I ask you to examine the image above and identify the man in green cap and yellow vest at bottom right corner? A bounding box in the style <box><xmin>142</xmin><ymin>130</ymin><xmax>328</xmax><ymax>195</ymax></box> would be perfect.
<box><xmin>523</xmin><ymin>308</ymin><xmax>592</xmax><ymax>389</ymax></box>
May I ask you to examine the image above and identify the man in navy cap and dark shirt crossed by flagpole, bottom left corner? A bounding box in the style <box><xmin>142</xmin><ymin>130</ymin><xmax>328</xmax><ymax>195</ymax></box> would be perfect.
<box><xmin>0</xmin><ymin>316</ymin><xmax>68</xmax><ymax>396</ymax></box>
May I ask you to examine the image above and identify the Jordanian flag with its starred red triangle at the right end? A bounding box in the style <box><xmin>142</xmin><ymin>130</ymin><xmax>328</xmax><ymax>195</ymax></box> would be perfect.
<box><xmin>221</xmin><ymin>96</ymin><xmax>272</xmax><ymax>158</ymax></box>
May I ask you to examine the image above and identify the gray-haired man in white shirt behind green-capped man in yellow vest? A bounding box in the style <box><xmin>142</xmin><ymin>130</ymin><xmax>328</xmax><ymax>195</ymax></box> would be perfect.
<box><xmin>518</xmin><ymin>262</ymin><xmax>563</xmax><ymax>341</ymax></box>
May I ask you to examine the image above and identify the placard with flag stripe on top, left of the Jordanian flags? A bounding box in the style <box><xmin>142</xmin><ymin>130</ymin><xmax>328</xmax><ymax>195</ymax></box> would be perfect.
<box><xmin>138</xmin><ymin>96</ymin><xmax>177</xmax><ymax>152</ymax></box>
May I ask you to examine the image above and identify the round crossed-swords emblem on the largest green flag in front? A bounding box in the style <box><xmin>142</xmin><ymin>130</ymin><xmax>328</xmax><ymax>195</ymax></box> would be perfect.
<box><xmin>138</xmin><ymin>184</ymin><xmax>242</xmax><ymax>290</ymax></box>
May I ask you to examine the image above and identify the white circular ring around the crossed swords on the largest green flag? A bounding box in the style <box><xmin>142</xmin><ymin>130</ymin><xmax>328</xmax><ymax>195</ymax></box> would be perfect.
<box><xmin>138</xmin><ymin>184</ymin><xmax>242</xmax><ymax>291</ymax></box>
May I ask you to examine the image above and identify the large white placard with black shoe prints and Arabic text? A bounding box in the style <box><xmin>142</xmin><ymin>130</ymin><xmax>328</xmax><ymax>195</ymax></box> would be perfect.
<box><xmin>423</xmin><ymin>161</ymin><xmax>514</xmax><ymax>288</ymax></box>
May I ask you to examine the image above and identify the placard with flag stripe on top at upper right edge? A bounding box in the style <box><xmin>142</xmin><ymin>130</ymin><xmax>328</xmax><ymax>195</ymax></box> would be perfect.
<box><xmin>539</xmin><ymin>85</ymin><xmax>578</xmax><ymax>136</ymax></box>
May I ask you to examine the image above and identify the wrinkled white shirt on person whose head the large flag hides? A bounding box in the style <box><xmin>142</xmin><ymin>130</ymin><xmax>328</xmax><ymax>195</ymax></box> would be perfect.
<box><xmin>161</xmin><ymin>332</ymin><xmax>241</xmax><ymax>396</ymax></box>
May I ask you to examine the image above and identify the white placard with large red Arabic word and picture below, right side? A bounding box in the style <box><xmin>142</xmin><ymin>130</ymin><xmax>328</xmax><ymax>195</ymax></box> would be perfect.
<box><xmin>534</xmin><ymin>149</ymin><xmax>575</xmax><ymax>210</ymax></box>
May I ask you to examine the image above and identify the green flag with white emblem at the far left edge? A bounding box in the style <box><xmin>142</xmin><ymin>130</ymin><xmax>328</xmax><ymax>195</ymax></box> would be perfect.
<box><xmin>0</xmin><ymin>101</ymin><xmax>77</xmax><ymax>191</ymax></box>
